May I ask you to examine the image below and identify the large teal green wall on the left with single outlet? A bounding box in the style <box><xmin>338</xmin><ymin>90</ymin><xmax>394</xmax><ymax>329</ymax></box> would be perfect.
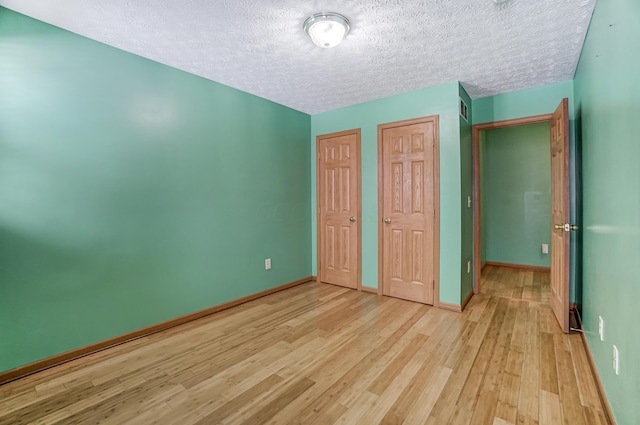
<box><xmin>0</xmin><ymin>8</ymin><xmax>312</xmax><ymax>371</ymax></box>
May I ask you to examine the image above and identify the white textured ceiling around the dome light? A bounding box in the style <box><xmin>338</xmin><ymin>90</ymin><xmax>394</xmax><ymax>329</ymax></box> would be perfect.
<box><xmin>0</xmin><ymin>0</ymin><xmax>596</xmax><ymax>114</ymax></box>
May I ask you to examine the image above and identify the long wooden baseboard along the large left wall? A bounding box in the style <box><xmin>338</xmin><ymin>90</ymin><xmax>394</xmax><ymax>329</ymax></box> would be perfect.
<box><xmin>0</xmin><ymin>276</ymin><xmax>314</xmax><ymax>385</ymax></box>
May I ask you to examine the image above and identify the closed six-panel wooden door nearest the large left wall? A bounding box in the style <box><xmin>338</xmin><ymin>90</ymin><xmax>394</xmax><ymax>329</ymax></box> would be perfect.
<box><xmin>316</xmin><ymin>129</ymin><xmax>361</xmax><ymax>289</ymax></box>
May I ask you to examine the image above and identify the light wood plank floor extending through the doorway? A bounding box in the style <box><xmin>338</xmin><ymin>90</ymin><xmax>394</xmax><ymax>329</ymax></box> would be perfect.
<box><xmin>0</xmin><ymin>267</ymin><xmax>606</xmax><ymax>425</ymax></box>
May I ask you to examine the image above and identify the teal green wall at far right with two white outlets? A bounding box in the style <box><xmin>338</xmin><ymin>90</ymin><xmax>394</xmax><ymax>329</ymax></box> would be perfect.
<box><xmin>575</xmin><ymin>0</ymin><xmax>640</xmax><ymax>425</ymax></box>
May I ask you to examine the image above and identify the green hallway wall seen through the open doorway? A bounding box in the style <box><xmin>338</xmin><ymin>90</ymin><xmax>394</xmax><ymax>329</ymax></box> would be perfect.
<box><xmin>481</xmin><ymin>123</ymin><xmax>551</xmax><ymax>267</ymax></box>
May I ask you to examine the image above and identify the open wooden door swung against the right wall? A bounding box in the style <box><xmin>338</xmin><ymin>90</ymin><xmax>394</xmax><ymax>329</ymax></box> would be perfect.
<box><xmin>551</xmin><ymin>99</ymin><xmax>571</xmax><ymax>332</ymax></box>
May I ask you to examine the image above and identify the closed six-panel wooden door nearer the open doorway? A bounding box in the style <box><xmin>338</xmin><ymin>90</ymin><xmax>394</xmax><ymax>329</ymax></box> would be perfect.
<box><xmin>378</xmin><ymin>116</ymin><xmax>439</xmax><ymax>304</ymax></box>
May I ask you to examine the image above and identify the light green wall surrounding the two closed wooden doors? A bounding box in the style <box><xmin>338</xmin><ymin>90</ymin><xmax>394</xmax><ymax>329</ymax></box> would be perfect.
<box><xmin>308</xmin><ymin>82</ymin><xmax>466</xmax><ymax>304</ymax></box>
